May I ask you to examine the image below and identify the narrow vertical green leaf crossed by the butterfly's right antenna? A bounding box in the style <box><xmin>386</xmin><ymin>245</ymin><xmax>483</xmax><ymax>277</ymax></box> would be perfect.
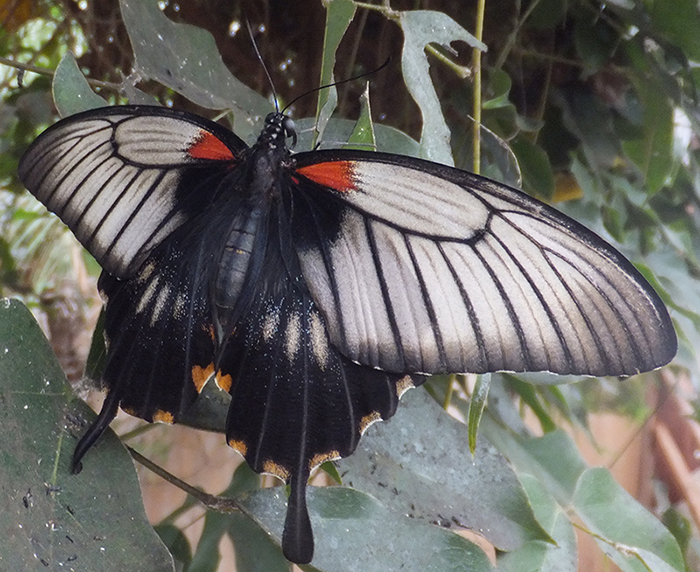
<box><xmin>314</xmin><ymin>0</ymin><xmax>355</xmax><ymax>145</ymax></box>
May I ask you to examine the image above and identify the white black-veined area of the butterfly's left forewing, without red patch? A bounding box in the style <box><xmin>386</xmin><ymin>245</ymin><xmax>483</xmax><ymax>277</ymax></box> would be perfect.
<box><xmin>20</xmin><ymin>114</ymin><xmax>201</xmax><ymax>278</ymax></box>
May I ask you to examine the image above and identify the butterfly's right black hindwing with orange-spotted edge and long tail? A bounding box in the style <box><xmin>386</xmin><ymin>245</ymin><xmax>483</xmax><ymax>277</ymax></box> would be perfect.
<box><xmin>217</xmin><ymin>201</ymin><xmax>423</xmax><ymax>563</ymax></box>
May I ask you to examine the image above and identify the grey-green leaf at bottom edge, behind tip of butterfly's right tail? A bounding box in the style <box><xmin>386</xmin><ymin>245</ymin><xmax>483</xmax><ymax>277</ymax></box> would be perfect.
<box><xmin>238</xmin><ymin>487</ymin><xmax>493</xmax><ymax>572</ymax></box>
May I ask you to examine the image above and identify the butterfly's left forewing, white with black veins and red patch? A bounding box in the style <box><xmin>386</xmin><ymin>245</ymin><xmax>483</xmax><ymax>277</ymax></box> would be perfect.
<box><xmin>19</xmin><ymin>106</ymin><xmax>246</xmax><ymax>278</ymax></box>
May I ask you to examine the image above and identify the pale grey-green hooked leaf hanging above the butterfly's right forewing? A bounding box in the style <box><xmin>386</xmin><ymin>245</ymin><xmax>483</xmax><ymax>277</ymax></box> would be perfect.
<box><xmin>399</xmin><ymin>10</ymin><xmax>486</xmax><ymax>165</ymax></box>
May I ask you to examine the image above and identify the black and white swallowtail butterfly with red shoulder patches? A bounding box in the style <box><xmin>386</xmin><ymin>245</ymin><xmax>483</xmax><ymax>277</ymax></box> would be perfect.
<box><xmin>19</xmin><ymin>106</ymin><xmax>677</xmax><ymax>563</ymax></box>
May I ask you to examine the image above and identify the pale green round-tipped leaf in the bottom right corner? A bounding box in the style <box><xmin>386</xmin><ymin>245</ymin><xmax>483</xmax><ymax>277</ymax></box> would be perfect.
<box><xmin>572</xmin><ymin>468</ymin><xmax>685</xmax><ymax>572</ymax></box>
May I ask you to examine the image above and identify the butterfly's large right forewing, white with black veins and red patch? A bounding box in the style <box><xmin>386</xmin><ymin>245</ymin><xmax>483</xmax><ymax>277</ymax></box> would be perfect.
<box><xmin>292</xmin><ymin>151</ymin><xmax>677</xmax><ymax>375</ymax></box>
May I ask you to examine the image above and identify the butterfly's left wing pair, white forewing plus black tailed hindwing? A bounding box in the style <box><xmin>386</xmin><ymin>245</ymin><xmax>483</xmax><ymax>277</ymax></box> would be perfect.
<box><xmin>19</xmin><ymin>106</ymin><xmax>248</xmax><ymax>464</ymax></box>
